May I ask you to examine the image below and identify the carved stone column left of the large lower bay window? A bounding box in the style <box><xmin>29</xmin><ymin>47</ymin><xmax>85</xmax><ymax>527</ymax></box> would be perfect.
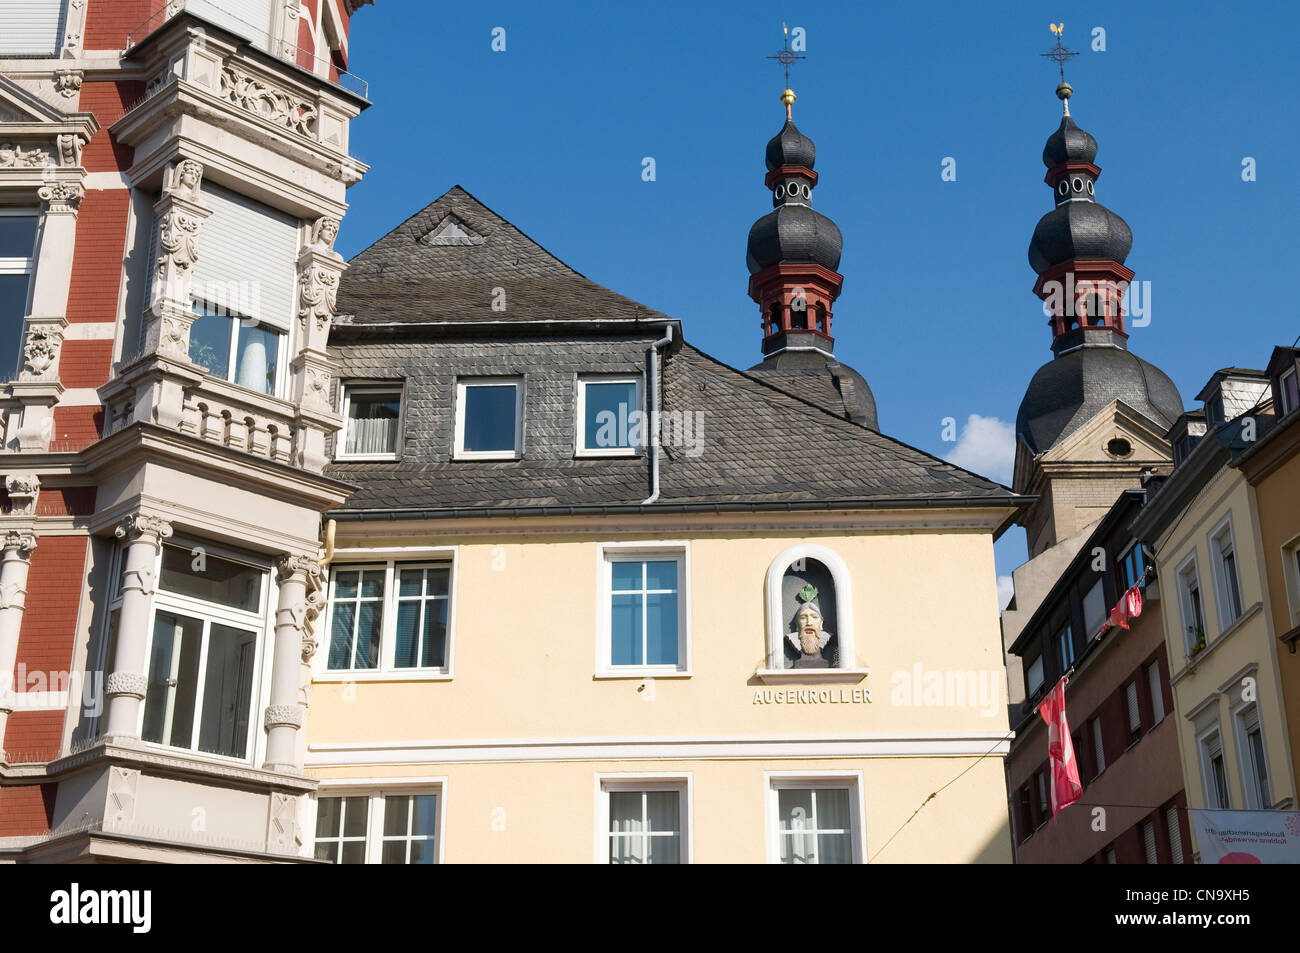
<box><xmin>104</xmin><ymin>514</ymin><xmax>172</xmax><ymax>738</ymax></box>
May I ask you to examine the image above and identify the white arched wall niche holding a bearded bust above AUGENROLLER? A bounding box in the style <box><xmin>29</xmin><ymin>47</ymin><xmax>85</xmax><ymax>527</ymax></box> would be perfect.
<box><xmin>761</xmin><ymin>543</ymin><xmax>862</xmax><ymax>677</ymax></box>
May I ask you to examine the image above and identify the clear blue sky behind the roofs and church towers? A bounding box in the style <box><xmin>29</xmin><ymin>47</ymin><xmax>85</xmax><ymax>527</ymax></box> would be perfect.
<box><xmin>338</xmin><ymin>0</ymin><xmax>1300</xmax><ymax>595</ymax></box>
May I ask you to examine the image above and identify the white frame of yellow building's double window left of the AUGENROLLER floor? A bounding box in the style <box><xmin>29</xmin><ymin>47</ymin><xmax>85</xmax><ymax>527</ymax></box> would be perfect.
<box><xmin>312</xmin><ymin>546</ymin><xmax>459</xmax><ymax>683</ymax></box>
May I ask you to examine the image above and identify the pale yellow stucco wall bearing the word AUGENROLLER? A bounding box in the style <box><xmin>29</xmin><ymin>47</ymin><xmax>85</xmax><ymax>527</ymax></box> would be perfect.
<box><xmin>307</xmin><ymin>525</ymin><xmax>1011</xmax><ymax>863</ymax></box>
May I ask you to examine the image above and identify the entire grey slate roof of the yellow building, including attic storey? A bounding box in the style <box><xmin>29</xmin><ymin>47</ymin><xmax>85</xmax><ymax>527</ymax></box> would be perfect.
<box><xmin>328</xmin><ymin>187</ymin><xmax>1030</xmax><ymax>517</ymax></box>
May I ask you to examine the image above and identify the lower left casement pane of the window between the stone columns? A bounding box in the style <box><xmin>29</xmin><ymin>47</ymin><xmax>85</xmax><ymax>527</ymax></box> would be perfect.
<box><xmin>142</xmin><ymin>612</ymin><xmax>203</xmax><ymax>748</ymax></box>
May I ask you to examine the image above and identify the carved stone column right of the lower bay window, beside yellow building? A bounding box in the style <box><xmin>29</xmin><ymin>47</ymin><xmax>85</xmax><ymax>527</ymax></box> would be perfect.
<box><xmin>263</xmin><ymin>553</ymin><xmax>321</xmax><ymax>774</ymax></box>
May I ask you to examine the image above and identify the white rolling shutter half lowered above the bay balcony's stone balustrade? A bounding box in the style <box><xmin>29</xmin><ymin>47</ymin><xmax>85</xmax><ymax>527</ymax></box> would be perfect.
<box><xmin>192</xmin><ymin>183</ymin><xmax>298</xmax><ymax>329</ymax></box>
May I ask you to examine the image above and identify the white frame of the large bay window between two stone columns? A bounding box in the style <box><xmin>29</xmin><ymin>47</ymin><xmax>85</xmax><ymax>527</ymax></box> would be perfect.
<box><xmin>133</xmin><ymin>537</ymin><xmax>276</xmax><ymax>764</ymax></box>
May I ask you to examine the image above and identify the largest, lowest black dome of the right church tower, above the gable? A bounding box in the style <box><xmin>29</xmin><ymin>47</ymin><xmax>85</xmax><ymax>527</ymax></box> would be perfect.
<box><xmin>1015</xmin><ymin>346</ymin><xmax>1183</xmax><ymax>454</ymax></box>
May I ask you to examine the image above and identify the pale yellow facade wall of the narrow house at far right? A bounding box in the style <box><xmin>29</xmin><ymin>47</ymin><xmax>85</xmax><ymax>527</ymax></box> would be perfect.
<box><xmin>1157</xmin><ymin>468</ymin><xmax>1295</xmax><ymax>839</ymax></box>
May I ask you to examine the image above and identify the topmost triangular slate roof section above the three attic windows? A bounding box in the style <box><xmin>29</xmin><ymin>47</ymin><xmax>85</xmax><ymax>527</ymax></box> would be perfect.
<box><xmin>338</xmin><ymin>186</ymin><xmax>667</xmax><ymax>324</ymax></box>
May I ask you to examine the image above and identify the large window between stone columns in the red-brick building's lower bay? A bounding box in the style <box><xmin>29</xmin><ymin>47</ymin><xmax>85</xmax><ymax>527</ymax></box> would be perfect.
<box><xmin>140</xmin><ymin>543</ymin><xmax>268</xmax><ymax>759</ymax></box>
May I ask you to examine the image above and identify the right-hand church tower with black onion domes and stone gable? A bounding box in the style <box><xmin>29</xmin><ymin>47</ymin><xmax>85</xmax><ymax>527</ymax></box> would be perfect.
<box><xmin>1013</xmin><ymin>63</ymin><xmax>1183</xmax><ymax>559</ymax></box>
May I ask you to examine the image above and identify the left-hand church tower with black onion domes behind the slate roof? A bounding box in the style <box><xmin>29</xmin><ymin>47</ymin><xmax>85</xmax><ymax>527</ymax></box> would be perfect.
<box><xmin>745</xmin><ymin>69</ymin><xmax>879</xmax><ymax>430</ymax></box>
